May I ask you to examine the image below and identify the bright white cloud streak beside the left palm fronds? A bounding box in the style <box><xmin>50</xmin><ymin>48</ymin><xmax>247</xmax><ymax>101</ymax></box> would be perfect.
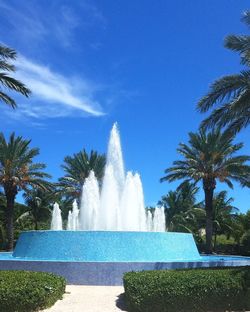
<box><xmin>4</xmin><ymin>56</ymin><xmax>104</xmax><ymax>119</ymax></box>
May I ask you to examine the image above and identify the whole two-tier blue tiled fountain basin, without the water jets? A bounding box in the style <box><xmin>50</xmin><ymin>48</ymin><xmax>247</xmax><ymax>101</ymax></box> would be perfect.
<box><xmin>0</xmin><ymin>231</ymin><xmax>250</xmax><ymax>285</ymax></box>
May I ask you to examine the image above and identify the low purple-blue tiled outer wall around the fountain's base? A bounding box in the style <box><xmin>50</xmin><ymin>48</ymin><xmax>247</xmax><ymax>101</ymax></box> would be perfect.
<box><xmin>0</xmin><ymin>260</ymin><xmax>250</xmax><ymax>286</ymax></box>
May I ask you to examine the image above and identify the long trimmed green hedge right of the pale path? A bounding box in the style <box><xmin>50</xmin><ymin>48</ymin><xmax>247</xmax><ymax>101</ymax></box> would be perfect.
<box><xmin>123</xmin><ymin>267</ymin><xmax>250</xmax><ymax>312</ymax></box>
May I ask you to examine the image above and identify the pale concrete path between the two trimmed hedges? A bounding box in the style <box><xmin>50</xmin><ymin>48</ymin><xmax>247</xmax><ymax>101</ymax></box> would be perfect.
<box><xmin>42</xmin><ymin>285</ymin><xmax>127</xmax><ymax>312</ymax></box>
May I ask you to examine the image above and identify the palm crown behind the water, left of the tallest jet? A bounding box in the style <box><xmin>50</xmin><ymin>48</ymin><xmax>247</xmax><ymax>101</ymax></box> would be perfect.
<box><xmin>58</xmin><ymin>149</ymin><xmax>106</xmax><ymax>199</ymax></box>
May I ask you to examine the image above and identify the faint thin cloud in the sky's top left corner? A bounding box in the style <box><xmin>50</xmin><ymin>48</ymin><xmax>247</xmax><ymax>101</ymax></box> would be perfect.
<box><xmin>0</xmin><ymin>0</ymin><xmax>106</xmax><ymax>47</ymax></box>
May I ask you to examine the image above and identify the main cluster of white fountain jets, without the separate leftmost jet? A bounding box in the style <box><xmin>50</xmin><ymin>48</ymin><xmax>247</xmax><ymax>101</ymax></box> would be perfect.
<box><xmin>49</xmin><ymin>123</ymin><xmax>165</xmax><ymax>231</ymax></box>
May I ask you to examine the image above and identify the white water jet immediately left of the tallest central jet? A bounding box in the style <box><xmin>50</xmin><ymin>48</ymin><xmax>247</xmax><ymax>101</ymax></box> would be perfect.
<box><xmin>79</xmin><ymin>171</ymin><xmax>101</xmax><ymax>231</ymax></box>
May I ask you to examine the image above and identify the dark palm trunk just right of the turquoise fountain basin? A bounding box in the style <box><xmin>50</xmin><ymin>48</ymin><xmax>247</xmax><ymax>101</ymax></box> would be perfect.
<box><xmin>203</xmin><ymin>180</ymin><xmax>215</xmax><ymax>254</ymax></box>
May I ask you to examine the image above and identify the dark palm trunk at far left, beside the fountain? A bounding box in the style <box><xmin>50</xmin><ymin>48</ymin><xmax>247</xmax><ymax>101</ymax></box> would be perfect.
<box><xmin>5</xmin><ymin>192</ymin><xmax>16</xmax><ymax>251</ymax></box>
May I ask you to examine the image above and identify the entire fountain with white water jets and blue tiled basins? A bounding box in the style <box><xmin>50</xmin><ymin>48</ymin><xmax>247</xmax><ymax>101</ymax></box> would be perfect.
<box><xmin>0</xmin><ymin>124</ymin><xmax>250</xmax><ymax>285</ymax></box>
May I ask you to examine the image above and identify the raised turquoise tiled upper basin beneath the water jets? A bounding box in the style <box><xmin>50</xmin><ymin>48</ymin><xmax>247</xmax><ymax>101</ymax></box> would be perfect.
<box><xmin>13</xmin><ymin>231</ymin><xmax>200</xmax><ymax>262</ymax></box>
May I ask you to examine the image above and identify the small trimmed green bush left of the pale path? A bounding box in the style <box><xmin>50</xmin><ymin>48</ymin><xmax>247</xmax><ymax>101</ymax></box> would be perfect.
<box><xmin>0</xmin><ymin>271</ymin><xmax>66</xmax><ymax>312</ymax></box>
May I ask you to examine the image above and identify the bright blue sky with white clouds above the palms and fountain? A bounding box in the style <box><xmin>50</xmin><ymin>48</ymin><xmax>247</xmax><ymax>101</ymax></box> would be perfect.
<box><xmin>0</xmin><ymin>0</ymin><xmax>250</xmax><ymax>211</ymax></box>
